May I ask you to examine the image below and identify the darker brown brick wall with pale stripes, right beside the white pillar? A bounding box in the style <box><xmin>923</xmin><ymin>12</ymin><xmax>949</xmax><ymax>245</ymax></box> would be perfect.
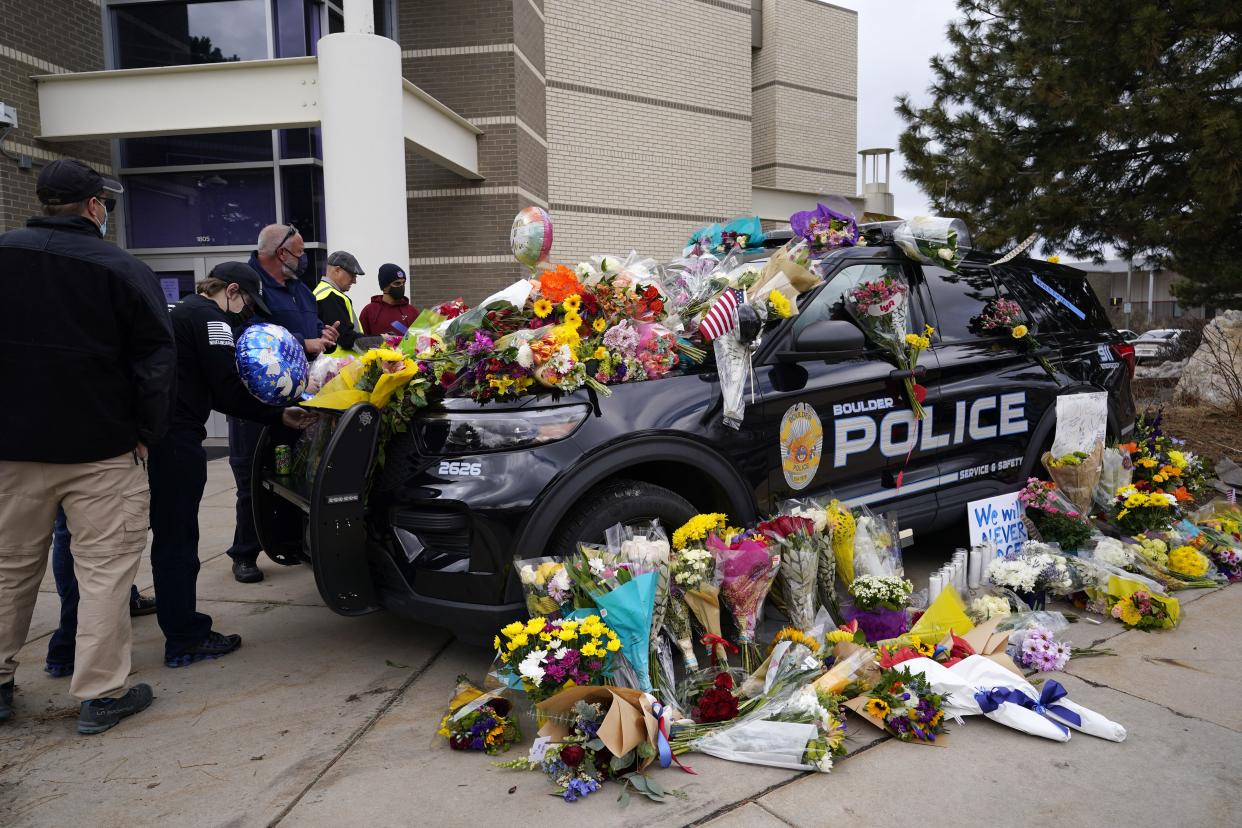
<box><xmin>397</xmin><ymin>0</ymin><xmax>548</xmax><ymax>304</ymax></box>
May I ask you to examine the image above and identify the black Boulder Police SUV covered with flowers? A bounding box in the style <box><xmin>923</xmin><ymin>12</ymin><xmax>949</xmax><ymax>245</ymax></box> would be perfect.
<box><xmin>253</xmin><ymin>222</ymin><xmax>1134</xmax><ymax>641</ymax></box>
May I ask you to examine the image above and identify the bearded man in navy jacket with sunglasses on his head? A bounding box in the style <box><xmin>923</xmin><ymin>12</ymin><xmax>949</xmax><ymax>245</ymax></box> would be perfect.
<box><xmin>229</xmin><ymin>225</ymin><xmax>338</xmax><ymax>583</ymax></box>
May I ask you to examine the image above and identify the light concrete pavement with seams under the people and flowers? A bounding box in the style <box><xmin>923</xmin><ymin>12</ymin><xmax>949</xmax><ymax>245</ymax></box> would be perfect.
<box><xmin>0</xmin><ymin>461</ymin><xmax>1242</xmax><ymax>828</ymax></box>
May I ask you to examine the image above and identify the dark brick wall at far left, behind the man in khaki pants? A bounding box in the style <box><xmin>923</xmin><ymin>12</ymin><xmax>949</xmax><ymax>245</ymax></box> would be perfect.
<box><xmin>0</xmin><ymin>0</ymin><xmax>114</xmax><ymax>236</ymax></box>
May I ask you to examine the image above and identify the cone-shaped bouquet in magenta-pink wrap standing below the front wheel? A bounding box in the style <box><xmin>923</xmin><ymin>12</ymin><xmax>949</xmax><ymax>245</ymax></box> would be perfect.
<box><xmin>707</xmin><ymin>531</ymin><xmax>780</xmax><ymax>673</ymax></box>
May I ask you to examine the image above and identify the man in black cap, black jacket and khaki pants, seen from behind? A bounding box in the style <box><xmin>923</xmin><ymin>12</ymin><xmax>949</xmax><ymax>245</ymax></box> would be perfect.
<box><xmin>0</xmin><ymin>160</ymin><xmax>176</xmax><ymax>734</ymax></box>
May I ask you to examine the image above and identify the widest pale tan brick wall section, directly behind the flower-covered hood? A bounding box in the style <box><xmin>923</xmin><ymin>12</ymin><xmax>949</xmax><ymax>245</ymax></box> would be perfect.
<box><xmin>544</xmin><ymin>0</ymin><xmax>751</xmax><ymax>261</ymax></box>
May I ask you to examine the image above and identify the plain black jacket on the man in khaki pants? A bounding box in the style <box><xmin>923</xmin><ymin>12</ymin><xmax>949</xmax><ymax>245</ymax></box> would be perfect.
<box><xmin>0</xmin><ymin>216</ymin><xmax>176</xmax><ymax>463</ymax></box>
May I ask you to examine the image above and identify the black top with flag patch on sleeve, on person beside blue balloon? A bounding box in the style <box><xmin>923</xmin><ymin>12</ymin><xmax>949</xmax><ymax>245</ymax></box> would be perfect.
<box><xmin>169</xmin><ymin>295</ymin><xmax>283</xmax><ymax>439</ymax></box>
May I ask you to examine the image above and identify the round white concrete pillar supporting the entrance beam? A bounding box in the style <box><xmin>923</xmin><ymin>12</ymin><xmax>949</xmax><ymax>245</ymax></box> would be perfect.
<box><xmin>319</xmin><ymin>33</ymin><xmax>410</xmax><ymax>304</ymax></box>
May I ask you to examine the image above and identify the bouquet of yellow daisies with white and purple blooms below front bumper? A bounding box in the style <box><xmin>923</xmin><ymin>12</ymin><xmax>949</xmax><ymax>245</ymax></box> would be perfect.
<box><xmin>493</xmin><ymin>614</ymin><xmax>621</xmax><ymax>701</ymax></box>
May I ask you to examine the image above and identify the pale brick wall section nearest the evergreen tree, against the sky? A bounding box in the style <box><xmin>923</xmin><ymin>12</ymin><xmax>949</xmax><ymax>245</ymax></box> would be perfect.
<box><xmin>751</xmin><ymin>0</ymin><xmax>858</xmax><ymax>195</ymax></box>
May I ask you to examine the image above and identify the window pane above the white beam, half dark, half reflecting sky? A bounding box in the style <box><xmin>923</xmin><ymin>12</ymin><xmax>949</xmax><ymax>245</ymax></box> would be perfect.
<box><xmin>112</xmin><ymin>0</ymin><xmax>268</xmax><ymax>70</ymax></box>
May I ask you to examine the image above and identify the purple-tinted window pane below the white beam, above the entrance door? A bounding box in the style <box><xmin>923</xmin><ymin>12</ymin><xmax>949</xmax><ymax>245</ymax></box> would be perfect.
<box><xmin>124</xmin><ymin>169</ymin><xmax>276</xmax><ymax>248</ymax></box>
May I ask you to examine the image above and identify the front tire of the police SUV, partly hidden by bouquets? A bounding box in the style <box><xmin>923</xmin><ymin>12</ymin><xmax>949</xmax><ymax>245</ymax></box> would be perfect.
<box><xmin>549</xmin><ymin>480</ymin><xmax>698</xmax><ymax>556</ymax></box>
